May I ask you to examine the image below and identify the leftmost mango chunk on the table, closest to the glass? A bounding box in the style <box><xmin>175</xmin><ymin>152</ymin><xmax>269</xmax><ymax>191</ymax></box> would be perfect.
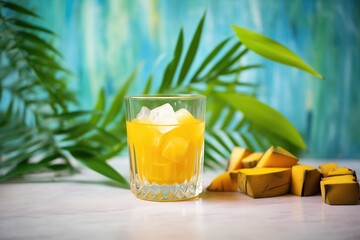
<box><xmin>206</xmin><ymin>172</ymin><xmax>238</xmax><ymax>192</ymax></box>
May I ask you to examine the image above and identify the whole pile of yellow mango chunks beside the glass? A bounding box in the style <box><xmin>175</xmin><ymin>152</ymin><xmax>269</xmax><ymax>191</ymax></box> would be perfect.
<box><xmin>207</xmin><ymin>146</ymin><xmax>359</xmax><ymax>205</ymax></box>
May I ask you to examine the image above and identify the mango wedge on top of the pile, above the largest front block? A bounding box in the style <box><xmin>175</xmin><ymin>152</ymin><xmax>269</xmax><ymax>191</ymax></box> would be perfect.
<box><xmin>256</xmin><ymin>146</ymin><xmax>299</xmax><ymax>168</ymax></box>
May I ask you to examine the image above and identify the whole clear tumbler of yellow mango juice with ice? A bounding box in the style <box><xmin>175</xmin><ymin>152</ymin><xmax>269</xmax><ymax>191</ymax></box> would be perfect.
<box><xmin>125</xmin><ymin>95</ymin><xmax>206</xmax><ymax>201</ymax></box>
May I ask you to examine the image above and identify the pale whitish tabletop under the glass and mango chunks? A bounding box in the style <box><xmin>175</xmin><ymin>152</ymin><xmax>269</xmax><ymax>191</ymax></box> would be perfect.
<box><xmin>0</xmin><ymin>158</ymin><xmax>360</xmax><ymax>240</ymax></box>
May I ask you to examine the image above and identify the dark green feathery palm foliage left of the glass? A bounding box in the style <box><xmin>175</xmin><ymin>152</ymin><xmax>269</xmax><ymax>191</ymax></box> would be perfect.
<box><xmin>0</xmin><ymin>1</ymin><xmax>129</xmax><ymax>187</ymax></box>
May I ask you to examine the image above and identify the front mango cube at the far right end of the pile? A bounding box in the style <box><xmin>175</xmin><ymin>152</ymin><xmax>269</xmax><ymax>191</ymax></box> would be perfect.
<box><xmin>321</xmin><ymin>175</ymin><xmax>359</xmax><ymax>205</ymax></box>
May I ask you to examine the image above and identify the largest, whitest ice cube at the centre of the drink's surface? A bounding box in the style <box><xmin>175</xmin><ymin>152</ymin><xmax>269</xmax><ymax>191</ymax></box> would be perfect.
<box><xmin>150</xmin><ymin>103</ymin><xmax>179</xmax><ymax>133</ymax></box>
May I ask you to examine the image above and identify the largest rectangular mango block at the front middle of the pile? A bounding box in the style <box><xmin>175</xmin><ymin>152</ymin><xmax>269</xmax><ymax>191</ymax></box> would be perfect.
<box><xmin>238</xmin><ymin>168</ymin><xmax>291</xmax><ymax>198</ymax></box>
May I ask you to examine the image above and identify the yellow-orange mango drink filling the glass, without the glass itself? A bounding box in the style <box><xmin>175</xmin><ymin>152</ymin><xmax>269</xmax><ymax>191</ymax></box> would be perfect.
<box><xmin>126</xmin><ymin>109</ymin><xmax>205</xmax><ymax>185</ymax></box>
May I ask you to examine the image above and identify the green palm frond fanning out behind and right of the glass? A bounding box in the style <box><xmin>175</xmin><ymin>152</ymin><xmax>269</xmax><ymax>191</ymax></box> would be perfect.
<box><xmin>141</xmin><ymin>14</ymin><xmax>312</xmax><ymax>168</ymax></box>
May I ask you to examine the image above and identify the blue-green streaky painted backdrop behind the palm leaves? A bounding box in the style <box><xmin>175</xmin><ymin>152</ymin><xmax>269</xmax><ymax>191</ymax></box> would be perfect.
<box><xmin>23</xmin><ymin>0</ymin><xmax>360</xmax><ymax>158</ymax></box>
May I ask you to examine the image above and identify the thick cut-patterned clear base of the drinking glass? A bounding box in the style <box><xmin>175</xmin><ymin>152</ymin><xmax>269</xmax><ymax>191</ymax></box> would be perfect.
<box><xmin>131</xmin><ymin>176</ymin><xmax>202</xmax><ymax>201</ymax></box>
